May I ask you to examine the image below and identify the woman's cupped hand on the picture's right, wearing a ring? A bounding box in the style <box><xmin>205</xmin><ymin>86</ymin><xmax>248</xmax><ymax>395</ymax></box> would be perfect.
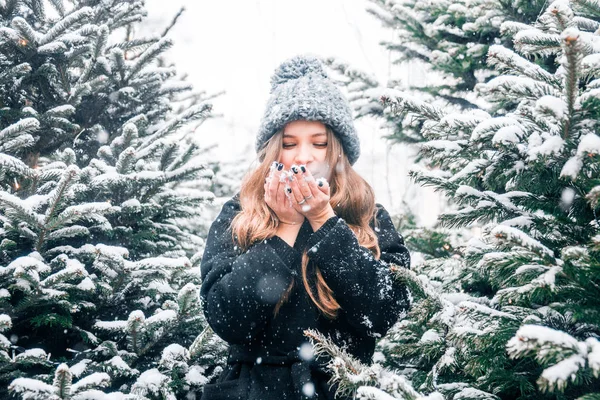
<box><xmin>290</xmin><ymin>165</ymin><xmax>335</xmax><ymax>225</ymax></box>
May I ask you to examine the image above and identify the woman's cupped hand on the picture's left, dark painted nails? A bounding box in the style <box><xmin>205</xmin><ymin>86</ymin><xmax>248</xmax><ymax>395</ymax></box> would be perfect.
<box><xmin>265</xmin><ymin>162</ymin><xmax>304</xmax><ymax>225</ymax></box>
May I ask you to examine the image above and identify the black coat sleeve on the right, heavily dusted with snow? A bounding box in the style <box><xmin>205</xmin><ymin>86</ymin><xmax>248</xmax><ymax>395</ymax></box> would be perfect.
<box><xmin>308</xmin><ymin>204</ymin><xmax>410</xmax><ymax>337</ymax></box>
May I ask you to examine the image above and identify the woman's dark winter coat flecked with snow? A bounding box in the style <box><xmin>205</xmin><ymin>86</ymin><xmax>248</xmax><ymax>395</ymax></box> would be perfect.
<box><xmin>201</xmin><ymin>195</ymin><xmax>410</xmax><ymax>400</ymax></box>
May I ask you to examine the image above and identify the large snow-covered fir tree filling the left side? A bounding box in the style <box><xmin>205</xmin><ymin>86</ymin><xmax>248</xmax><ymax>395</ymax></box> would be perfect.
<box><xmin>0</xmin><ymin>0</ymin><xmax>230</xmax><ymax>399</ymax></box>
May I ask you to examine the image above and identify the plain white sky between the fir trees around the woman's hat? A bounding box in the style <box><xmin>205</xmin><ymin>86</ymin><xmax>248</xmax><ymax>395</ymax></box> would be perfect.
<box><xmin>145</xmin><ymin>0</ymin><xmax>446</xmax><ymax>225</ymax></box>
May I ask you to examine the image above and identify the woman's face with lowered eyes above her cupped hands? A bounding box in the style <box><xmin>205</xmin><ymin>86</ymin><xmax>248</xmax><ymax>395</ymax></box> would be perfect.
<box><xmin>279</xmin><ymin>121</ymin><xmax>330</xmax><ymax>180</ymax></box>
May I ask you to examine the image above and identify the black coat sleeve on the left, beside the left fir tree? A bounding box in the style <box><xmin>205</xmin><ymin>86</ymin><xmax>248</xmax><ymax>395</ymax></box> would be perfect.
<box><xmin>200</xmin><ymin>197</ymin><xmax>301</xmax><ymax>344</ymax></box>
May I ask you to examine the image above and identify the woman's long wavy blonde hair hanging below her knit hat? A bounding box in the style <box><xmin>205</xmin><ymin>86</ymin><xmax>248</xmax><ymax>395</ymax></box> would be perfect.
<box><xmin>231</xmin><ymin>126</ymin><xmax>380</xmax><ymax>319</ymax></box>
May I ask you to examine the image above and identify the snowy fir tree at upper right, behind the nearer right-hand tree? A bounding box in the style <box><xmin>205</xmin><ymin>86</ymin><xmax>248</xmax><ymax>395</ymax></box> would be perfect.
<box><xmin>328</xmin><ymin>0</ymin><xmax>554</xmax><ymax>143</ymax></box>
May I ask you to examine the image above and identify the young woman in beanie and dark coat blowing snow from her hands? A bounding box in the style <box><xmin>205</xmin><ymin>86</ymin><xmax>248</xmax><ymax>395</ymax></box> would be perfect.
<box><xmin>201</xmin><ymin>57</ymin><xmax>410</xmax><ymax>400</ymax></box>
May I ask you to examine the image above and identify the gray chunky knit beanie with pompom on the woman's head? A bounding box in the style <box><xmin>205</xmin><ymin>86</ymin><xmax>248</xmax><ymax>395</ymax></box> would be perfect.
<box><xmin>256</xmin><ymin>56</ymin><xmax>360</xmax><ymax>164</ymax></box>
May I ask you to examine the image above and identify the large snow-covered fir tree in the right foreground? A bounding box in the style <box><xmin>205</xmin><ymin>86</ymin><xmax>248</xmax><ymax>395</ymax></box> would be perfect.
<box><xmin>324</xmin><ymin>0</ymin><xmax>600</xmax><ymax>399</ymax></box>
